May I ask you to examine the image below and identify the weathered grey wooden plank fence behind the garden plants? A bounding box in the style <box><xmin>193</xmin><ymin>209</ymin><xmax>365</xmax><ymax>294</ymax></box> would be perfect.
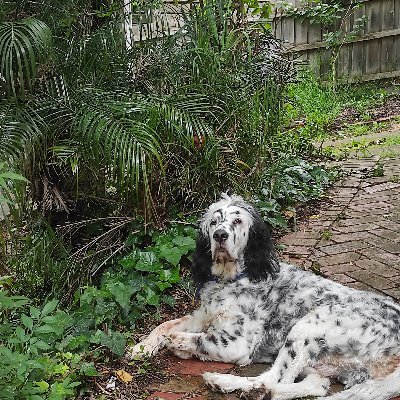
<box><xmin>132</xmin><ymin>0</ymin><xmax>400</xmax><ymax>82</ymax></box>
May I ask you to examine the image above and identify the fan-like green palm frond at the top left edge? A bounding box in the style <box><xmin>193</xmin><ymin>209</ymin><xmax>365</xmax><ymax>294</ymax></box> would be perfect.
<box><xmin>0</xmin><ymin>18</ymin><xmax>52</xmax><ymax>98</ymax></box>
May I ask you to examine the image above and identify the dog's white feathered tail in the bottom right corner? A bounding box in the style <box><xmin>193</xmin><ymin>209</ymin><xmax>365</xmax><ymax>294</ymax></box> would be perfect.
<box><xmin>318</xmin><ymin>365</ymin><xmax>400</xmax><ymax>400</ymax></box>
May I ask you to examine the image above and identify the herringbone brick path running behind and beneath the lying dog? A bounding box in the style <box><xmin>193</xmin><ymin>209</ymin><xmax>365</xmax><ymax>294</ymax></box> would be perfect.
<box><xmin>149</xmin><ymin>157</ymin><xmax>400</xmax><ymax>400</ymax></box>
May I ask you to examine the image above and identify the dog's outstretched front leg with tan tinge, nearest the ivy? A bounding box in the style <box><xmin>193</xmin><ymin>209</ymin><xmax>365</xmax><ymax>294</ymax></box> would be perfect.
<box><xmin>125</xmin><ymin>315</ymin><xmax>194</xmax><ymax>360</ymax></box>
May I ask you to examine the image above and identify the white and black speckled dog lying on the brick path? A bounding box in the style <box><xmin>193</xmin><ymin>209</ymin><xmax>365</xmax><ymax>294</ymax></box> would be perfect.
<box><xmin>127</xmin><ymin>195</ymin><xmax>400</xmax><ymax>400</ymax></box>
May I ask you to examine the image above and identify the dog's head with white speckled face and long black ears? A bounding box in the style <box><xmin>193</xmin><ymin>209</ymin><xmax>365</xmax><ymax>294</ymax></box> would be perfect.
<box><xmin>192</xmin><ymin>194</ymin><xmax>279</xmax><ymax>285</ymax></box>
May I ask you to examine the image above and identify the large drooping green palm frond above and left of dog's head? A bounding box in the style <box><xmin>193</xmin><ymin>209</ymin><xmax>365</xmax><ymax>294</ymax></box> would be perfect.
<box><xmin>74</xmin><ymin>105</ymin><xmax>163</xmax><ymax>207</ymax></box>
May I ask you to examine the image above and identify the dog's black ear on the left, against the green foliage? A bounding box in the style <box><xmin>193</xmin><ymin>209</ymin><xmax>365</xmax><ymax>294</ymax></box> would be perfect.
<box><xmin>192</xmin><ymin>230</ymin><xmax>212</xmax><ymax>287</ymax></box>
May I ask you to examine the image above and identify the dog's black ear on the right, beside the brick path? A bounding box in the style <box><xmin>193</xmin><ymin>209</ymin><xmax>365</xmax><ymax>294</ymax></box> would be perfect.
<box><xmin>244</xmin><ymin>211</ymin><xmax>279</xmax><ymax>280</ymax></box>
